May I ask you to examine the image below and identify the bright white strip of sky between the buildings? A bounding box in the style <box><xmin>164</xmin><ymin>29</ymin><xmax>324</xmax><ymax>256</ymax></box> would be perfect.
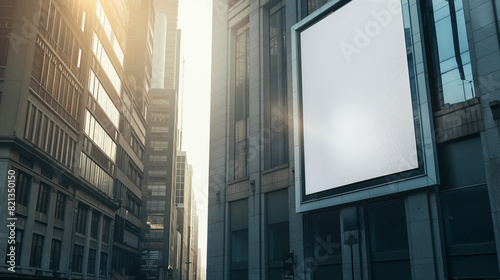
<box><xmin>178</xmin><ymin>0</ymin><xmax>212</xmax><ymax>274</ymax></box>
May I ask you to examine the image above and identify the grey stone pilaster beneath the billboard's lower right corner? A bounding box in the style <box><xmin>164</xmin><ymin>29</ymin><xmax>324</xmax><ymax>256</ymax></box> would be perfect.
<box><xmin>406</xmin><ymin>192</ymin><xmax>436</xmax><ymax>280</ymax></box>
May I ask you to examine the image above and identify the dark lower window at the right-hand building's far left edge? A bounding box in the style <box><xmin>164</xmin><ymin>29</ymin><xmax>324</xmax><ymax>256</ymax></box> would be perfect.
<box><xmin>229</xmin><ymin>199</ymin><xmax>248</xmax><ymax>280</ymax></box>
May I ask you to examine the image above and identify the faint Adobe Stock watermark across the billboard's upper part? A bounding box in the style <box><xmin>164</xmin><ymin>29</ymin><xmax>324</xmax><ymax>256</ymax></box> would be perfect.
<box><xmin>339</xmin><ymin>0</ymin><xmax>401</xmax><ymax>63</ymax></box>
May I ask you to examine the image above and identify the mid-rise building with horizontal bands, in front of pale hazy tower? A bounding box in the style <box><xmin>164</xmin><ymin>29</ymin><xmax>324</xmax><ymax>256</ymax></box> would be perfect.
<box><xmin>141</xmin><ymin>89</ymin><xmax>180</xmax><ymax>279</ymax></box>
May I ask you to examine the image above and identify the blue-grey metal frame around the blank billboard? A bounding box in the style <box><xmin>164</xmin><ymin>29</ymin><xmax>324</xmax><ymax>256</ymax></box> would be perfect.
<box><xmin>291</xmin><ymin>0</ymin><xmax>439</xmax><ymax>213</ymax></box>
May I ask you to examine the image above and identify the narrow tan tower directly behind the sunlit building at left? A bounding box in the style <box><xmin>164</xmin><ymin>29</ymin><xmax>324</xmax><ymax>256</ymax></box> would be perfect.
<box><xmin>111</xmin><ymin>0</ymin><xmax>155</xmax><ymax>278</ymax></box>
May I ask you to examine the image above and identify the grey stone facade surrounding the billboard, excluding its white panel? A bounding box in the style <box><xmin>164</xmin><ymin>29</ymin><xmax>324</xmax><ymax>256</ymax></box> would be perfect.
<box><xmin>207</xmin><ymin>0</ymin><xmax>500</xmax><ymax>280</ymax></box>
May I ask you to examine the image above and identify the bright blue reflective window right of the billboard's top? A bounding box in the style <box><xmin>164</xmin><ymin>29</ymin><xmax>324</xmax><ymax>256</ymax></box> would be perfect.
<box><xmin>426</xmin><ymin>0</ymin><xmax>476</xmax><ymax>110</ymax></box>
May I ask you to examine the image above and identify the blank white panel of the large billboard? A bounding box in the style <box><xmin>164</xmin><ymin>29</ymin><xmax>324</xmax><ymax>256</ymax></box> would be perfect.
<box><xmin>300</xmin><ymin>0</ymin><xmax>419</xmax><ymax>195</ymax></box>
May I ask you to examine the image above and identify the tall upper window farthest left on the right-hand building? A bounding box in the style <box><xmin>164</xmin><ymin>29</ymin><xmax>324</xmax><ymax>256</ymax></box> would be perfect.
<box><xmin>234</xmin><ymin>25</ymin><xmax>250</xmax><ymax>179</ymax></box>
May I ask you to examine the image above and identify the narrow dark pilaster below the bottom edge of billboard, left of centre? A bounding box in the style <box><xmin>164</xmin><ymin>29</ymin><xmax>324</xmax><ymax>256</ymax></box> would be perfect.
<box><xmin>340</xmin><ymin>205</ymin><xmax>362</xmax><ymax>280</ymax></box>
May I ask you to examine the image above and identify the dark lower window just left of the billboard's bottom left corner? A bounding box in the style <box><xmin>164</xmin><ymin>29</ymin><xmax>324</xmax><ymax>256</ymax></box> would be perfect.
<box><xmin>266</xmin><ymin>189</ymin><xmax>290</xmax><ymax>279</ymax></box>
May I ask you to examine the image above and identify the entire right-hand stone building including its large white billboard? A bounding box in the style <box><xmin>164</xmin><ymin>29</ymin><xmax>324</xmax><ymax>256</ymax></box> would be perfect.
<box><xmin>207</xmin><ymin>0</ymin><xmax>500</xmax><ymax>280</ymax></box>
